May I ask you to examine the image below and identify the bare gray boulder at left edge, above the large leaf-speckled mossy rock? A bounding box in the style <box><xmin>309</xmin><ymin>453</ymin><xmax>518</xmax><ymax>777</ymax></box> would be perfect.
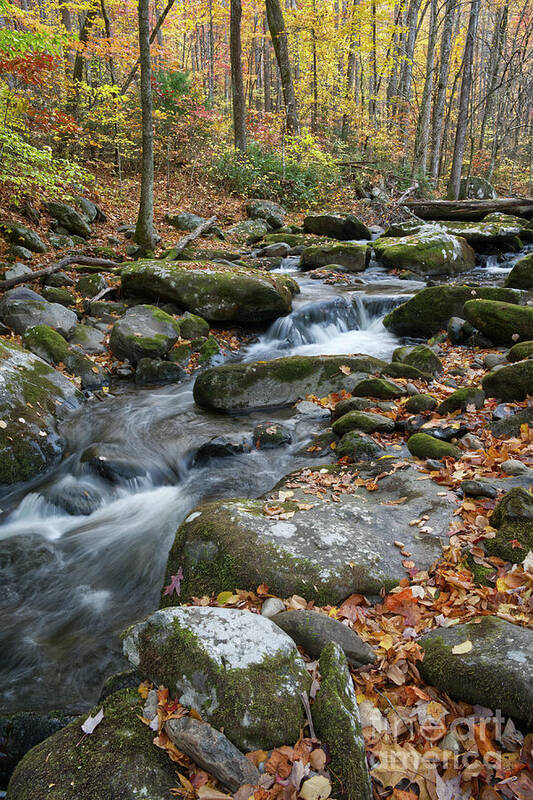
<box><xmin>0</xmin><ymin>286</ymin><xmax>78</xmax><ymax>339</ymax></box>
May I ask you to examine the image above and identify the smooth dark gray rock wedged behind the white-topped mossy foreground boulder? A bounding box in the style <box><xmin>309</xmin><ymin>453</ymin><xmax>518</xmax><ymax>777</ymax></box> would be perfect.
<box><xmin>272</xmin><ymin>610</ymin><xmax>376</xmax><ymax>667</ymax></box>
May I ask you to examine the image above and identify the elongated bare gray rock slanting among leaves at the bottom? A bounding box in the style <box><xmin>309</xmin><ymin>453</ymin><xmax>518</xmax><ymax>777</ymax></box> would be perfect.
<box><xmin>165</xmin><ymin>717</ymin><xmax>261</xmax><ymax>792</ymax></box>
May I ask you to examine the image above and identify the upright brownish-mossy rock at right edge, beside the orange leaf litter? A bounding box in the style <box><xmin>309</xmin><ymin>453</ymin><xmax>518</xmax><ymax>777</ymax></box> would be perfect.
<box><xmin>484</xmin><ymin>488</ymin><xmax>533</xmax><ymax>564</ymax></box>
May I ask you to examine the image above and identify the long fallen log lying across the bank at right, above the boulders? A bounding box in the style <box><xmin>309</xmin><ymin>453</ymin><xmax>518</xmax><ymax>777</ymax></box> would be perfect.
<box><xmin>404</xmin><ymin>197</ymin><xmax>533</xmax><ymax>222</ymax></box>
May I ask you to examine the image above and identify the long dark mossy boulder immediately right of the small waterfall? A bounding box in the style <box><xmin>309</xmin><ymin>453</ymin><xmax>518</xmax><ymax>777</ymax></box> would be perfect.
<box><xmin>383</xmin><ymin>286</ymin><xmax>520</xmax><ymax>338</ymax></box>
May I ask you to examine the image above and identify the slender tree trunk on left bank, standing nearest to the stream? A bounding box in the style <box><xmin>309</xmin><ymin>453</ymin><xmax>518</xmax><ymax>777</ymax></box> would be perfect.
<box><xmin>134</xmin><ymin>0</ymin><xmax>156</xmax><ymax>253</ymax></box>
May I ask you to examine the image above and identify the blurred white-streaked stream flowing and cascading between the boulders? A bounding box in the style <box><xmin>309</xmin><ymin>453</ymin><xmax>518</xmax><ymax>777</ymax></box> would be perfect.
<box><xmin>0</xmin><ymin>247</ymin><xmax>522</xmax><ymax>711</ymax></box>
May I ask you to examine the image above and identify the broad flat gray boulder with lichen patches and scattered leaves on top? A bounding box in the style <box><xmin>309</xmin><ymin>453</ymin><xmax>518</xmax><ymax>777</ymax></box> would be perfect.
<box><xmin>162</xmin><ymin>460</ymin><xmax>455</xmax><ymax>605</ymax></box>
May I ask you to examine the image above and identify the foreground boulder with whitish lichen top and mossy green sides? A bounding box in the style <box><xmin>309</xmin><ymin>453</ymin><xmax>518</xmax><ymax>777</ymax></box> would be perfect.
<box><xmin>124</xmin><ymin>606</ymin><xmax>311</xmax><ymax>750</ymax></box>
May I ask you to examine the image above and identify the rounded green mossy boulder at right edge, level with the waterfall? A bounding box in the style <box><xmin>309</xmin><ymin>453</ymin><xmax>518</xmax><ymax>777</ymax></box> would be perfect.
<box><xmin>464</xmin><ymin>300</ymin><xmax>533</xmax><ymax>345</ymax></box>
